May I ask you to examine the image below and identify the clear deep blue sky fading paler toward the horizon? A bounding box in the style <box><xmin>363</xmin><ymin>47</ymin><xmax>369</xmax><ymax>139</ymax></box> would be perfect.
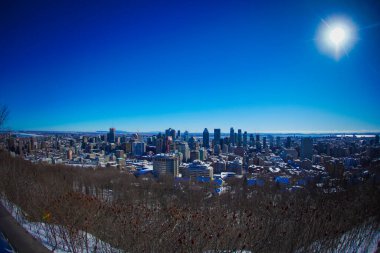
<box><xmin>0</xmin><ymin>0</ymin><xmax>380</xmax><ymax>132</ymax></box>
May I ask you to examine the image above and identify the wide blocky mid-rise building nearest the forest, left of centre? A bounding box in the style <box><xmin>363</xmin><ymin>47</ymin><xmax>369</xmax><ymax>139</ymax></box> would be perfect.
<box><xmin>153</xmin><ymin>154</ymin><xmax>179</xmax><ymax>177</ymax></box>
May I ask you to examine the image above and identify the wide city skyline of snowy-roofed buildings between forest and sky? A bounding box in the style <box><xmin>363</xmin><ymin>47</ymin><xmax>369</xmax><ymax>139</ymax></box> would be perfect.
<box><xmin>0</xmin><ymin>128</ymin><xmax>380</xmax><ymax>191</ymax></box>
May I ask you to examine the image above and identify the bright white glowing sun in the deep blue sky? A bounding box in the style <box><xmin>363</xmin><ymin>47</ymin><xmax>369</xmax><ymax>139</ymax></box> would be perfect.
<box><xmin>316</xmin><ymin>17</ymin><xmax>357</xmax><ymax>60</ymax></box>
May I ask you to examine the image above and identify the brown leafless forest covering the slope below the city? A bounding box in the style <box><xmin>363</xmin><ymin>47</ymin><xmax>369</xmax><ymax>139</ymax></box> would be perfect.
<box><xmin>0</xmin><ymin>152</ymin><xmax>380</xmax><ymax>252</ymax></box>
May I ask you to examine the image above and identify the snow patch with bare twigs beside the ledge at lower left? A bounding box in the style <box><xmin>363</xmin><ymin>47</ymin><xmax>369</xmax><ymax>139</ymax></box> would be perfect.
<box><xmin>0</xmin><ymin>197</ymin><xmax>123</xmax><ymax>253</ymax></box>
